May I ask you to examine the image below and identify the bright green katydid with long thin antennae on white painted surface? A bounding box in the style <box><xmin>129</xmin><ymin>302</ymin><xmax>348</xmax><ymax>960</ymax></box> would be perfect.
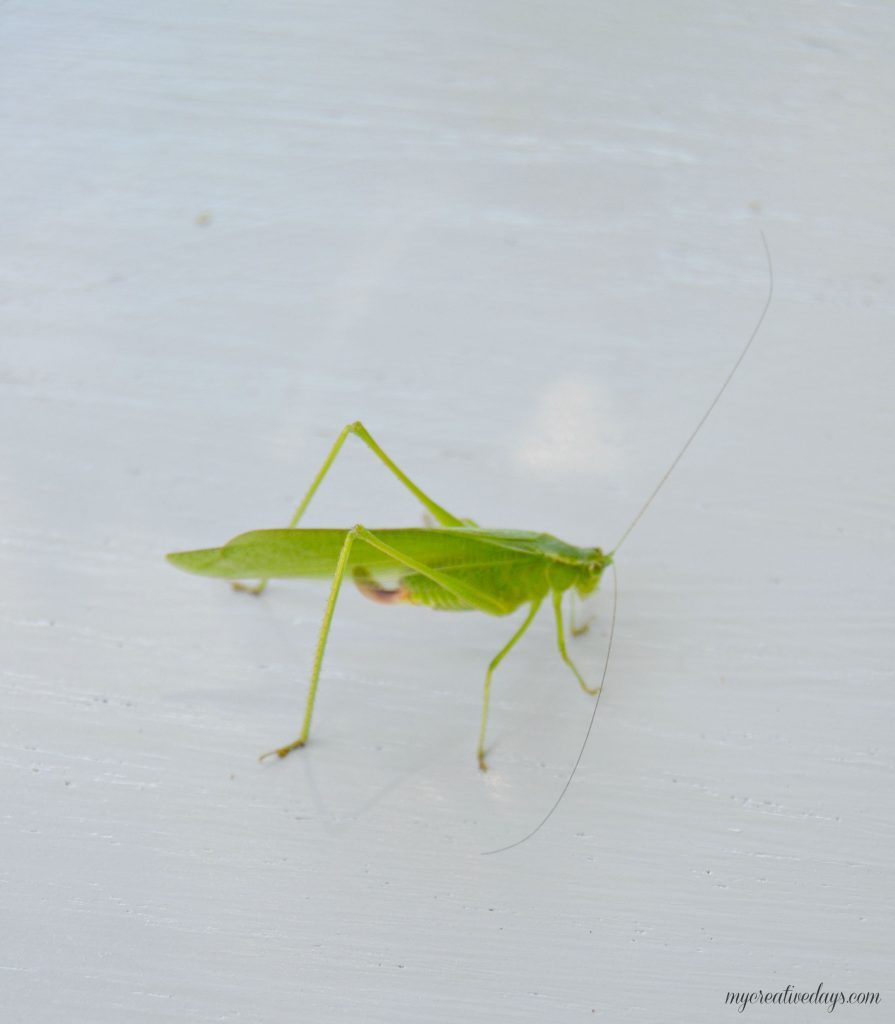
<box><xmin>168</xmin><ymin>236</ymin><xmax>773</xmax><ymax>782</ymax></box>
